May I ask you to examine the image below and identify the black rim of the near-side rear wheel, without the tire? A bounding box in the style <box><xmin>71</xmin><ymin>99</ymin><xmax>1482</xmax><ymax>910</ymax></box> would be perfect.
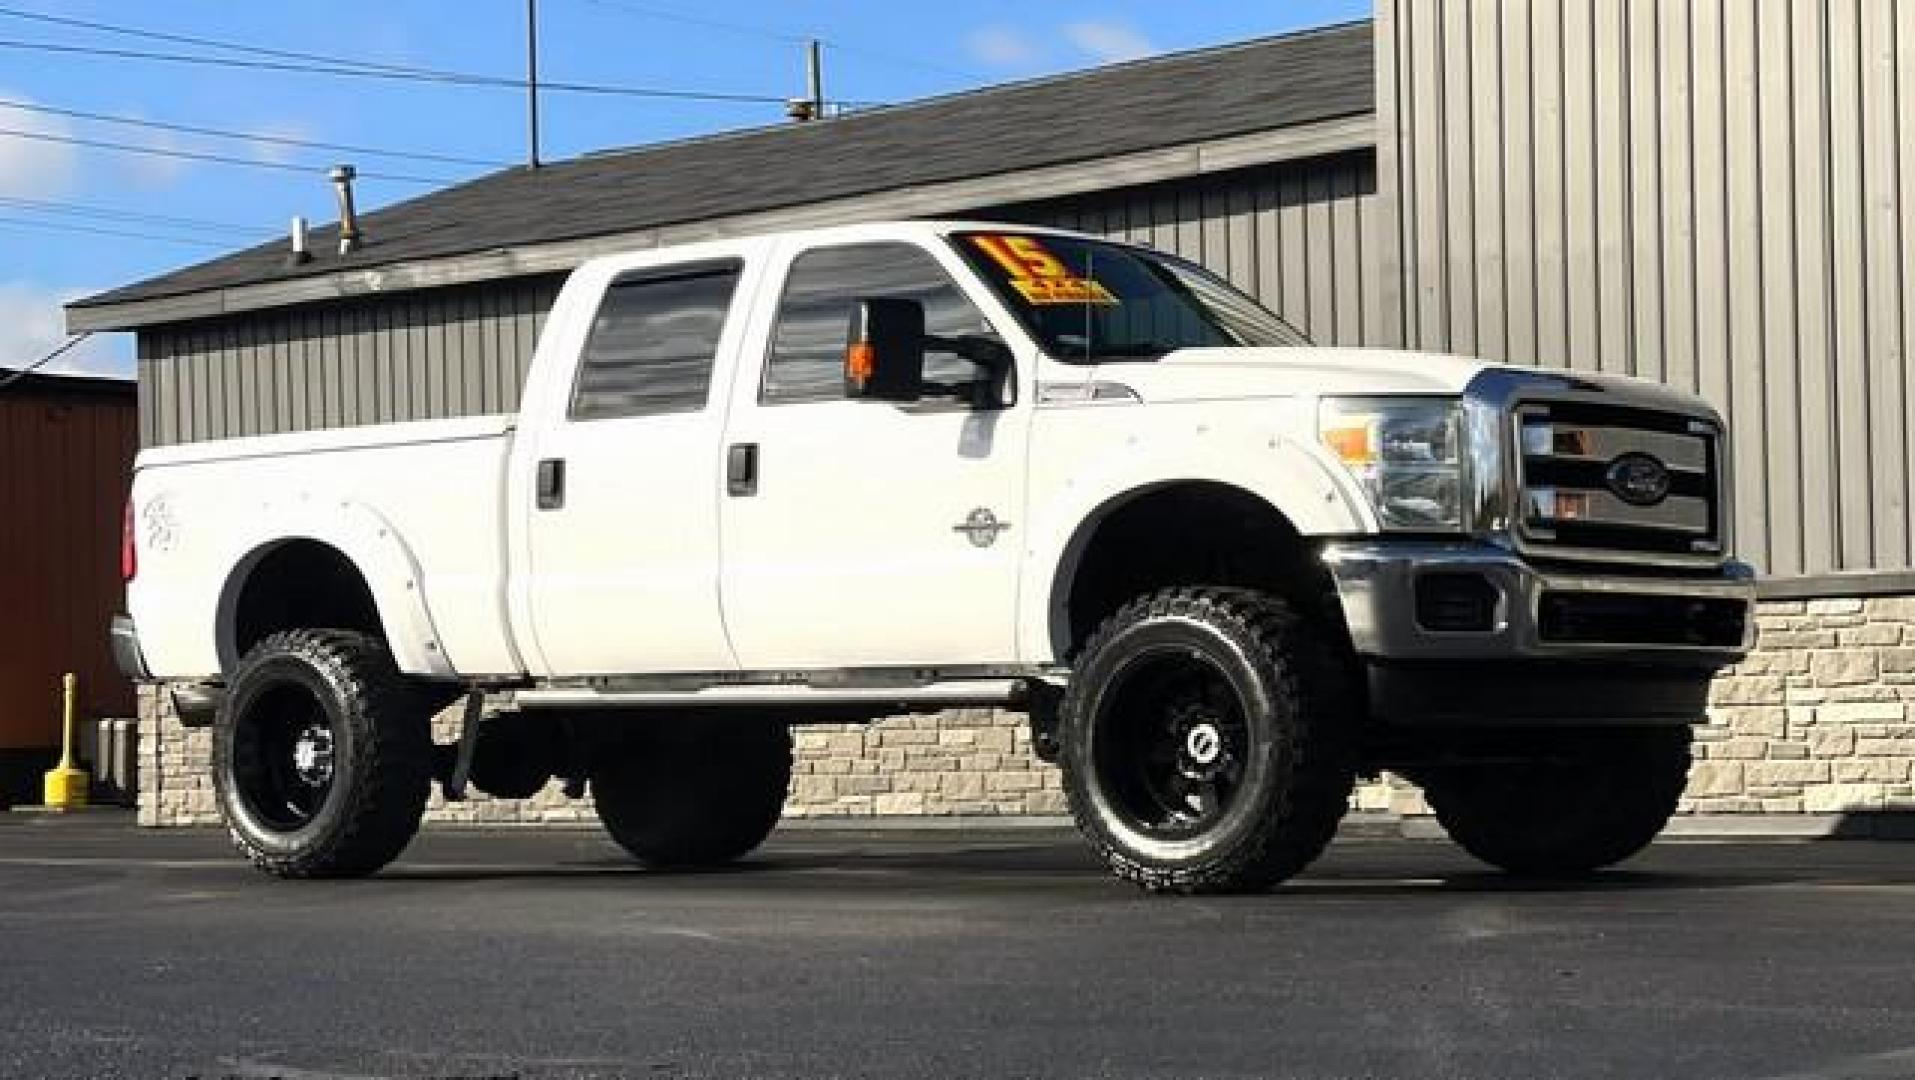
<box><xmin>234</xmin><ymin>686</ymin><xmax>339</xmax><ymax>833</ymax></box>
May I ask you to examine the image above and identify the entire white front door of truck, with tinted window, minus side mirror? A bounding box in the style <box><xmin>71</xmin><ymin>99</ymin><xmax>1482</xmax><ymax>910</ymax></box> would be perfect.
<box><xmin>722</xmin><ymin>243</ymin><xmax>1030</xmax><ymax>670</ymax></box>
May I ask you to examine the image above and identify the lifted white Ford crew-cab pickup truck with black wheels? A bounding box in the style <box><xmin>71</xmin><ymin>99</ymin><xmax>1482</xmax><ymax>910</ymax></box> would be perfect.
<box><xmin>113</xmin><ymin>222</ymin><xmax>1754</xmax><ymax>892</ymax></box>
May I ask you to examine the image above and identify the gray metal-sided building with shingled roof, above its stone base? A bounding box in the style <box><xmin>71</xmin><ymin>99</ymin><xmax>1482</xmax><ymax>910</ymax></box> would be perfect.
<box><xmin>71</xmin><ymin>0</ymin><xmax>1915</xmax><ymax>594</ymax></box>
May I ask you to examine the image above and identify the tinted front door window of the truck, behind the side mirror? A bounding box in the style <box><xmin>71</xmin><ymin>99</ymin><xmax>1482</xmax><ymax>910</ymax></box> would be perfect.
<box><xmin>762</xmin><ymin>243</ymin><xmax>1002</xmax><ymax>402</ymax></box>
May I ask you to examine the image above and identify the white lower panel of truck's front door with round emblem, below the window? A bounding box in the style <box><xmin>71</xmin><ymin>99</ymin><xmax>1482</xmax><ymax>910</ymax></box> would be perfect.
<box><xmin>724</xmin><ymin>402</ymin><xmax>1025</xmax><ymax>670</ymax></box>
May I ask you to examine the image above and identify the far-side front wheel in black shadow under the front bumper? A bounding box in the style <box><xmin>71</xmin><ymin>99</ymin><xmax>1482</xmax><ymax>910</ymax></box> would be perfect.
<box><xmin>1415</xmin><ymin>728</ymin><xmax>1691</xmax><ymax>877</ymax></box>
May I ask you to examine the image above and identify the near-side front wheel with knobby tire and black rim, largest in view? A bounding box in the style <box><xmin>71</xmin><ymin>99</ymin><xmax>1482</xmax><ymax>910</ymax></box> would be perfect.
<box><xmin>1059</xmin><ymin>588</ymin><xmax>1358</xmax><ymax>892</ymax></box>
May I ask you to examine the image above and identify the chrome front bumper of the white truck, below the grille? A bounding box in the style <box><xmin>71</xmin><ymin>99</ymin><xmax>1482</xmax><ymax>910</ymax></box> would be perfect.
<box><xmin>1323</xmin><ymin>540</ymin><xmax>1756</xmax><ymax>668</ymax></box>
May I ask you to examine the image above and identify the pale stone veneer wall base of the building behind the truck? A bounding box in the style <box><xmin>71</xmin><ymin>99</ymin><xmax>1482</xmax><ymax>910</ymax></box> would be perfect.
<box><xmin>140</xmin><ymin>597</ymin><xmax>1915</xmax><ymax>825</ymax></box>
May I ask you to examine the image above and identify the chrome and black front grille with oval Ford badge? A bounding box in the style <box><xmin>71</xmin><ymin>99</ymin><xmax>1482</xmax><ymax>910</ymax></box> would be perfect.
<box><xmin>1513</xmin><ymin>402</ymin><xmax>1725</xmax><ymax>561</ymax></box>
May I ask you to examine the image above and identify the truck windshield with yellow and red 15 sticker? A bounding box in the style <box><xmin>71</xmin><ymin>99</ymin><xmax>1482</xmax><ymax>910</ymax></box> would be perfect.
<box><xmin>952</xmin><ymin>232</ymin><xmax>1310</xmax><ymax>364</ymax></box>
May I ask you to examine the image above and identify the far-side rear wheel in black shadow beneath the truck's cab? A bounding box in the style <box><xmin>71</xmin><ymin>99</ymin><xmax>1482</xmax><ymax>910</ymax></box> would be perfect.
<box><xmin>592</xmin><ymin>718</ymin><xmax>791</xmax><ymax>867</ymax></box>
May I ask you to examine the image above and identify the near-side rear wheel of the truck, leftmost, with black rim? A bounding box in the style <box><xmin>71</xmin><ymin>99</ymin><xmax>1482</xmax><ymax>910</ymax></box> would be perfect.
<box><xmin>213</xmin><ymin>630</ymin><xmax>433</xmax><ymax>877</ymax></box>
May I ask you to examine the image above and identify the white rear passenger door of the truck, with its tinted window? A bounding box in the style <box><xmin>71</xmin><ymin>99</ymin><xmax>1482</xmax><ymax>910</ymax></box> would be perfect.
<box><xmin>519</xmin><ymin>259</ymin><xmax>745</xmax><ymax>674</ymax></box>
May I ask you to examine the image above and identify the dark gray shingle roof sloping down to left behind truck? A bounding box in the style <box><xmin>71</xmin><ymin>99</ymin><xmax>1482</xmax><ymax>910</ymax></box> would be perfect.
<box><xmin>71</xmin><ymin>23</ymin><xmax>1375</xmax><ymax>308</ymax></box>
